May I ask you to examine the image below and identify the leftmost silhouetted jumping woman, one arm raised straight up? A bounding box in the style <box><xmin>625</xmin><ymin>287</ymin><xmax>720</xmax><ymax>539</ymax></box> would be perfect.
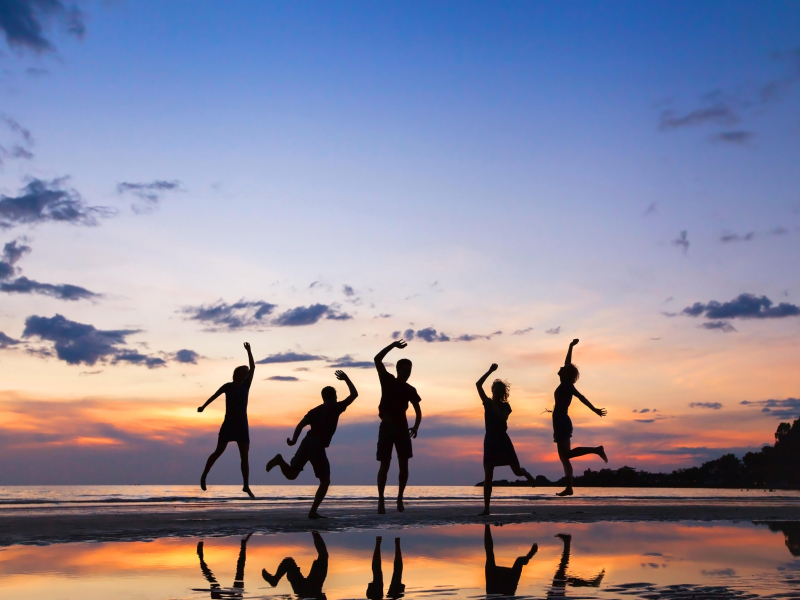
<box><xmin>197</xmin><ymin>342</ymin><xmax>256</xmax><ymax>499</ymax></box>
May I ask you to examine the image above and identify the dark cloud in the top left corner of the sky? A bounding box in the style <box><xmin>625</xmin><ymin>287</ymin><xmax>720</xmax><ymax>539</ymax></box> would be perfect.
<box><xmin>0</xmin><ymin>0</ymin><xmax>86</xmax><ymax>54</ymax></box>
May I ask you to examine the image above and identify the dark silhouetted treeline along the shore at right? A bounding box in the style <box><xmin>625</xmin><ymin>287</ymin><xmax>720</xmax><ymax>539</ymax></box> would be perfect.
<box><xmin>476</xmin><ymin>418</ymin><xmax>800</xmax><ymax>489</ymax></box>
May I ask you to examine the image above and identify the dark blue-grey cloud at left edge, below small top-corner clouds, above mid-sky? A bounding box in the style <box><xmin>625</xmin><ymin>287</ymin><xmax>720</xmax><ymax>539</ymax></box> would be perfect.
<box><xmin>0</xmin><ymin>177</ymin><xmax>115</xmax><ymax>229</ymax></box>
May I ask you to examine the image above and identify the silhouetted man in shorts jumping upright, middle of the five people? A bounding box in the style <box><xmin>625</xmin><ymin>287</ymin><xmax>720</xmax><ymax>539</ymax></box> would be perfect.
<box><xmin>375</xmin><ymin>340</ymin><xmax>422</xmax><ymax>515</ymax></box>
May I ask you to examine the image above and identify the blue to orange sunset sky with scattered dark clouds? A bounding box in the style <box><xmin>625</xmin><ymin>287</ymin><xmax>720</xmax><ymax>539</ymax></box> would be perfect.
<box><xmin>0</xmin><ymin>0</ymin><xmax>800</xmax><ymax>485</ymax></box>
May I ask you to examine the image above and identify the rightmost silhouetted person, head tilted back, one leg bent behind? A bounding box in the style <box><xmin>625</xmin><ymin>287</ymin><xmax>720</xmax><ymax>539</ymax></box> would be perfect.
<box><xmin>552</xmin><ymin>339</ymin><xmax>608</xmax><ymax>496</ymax></box>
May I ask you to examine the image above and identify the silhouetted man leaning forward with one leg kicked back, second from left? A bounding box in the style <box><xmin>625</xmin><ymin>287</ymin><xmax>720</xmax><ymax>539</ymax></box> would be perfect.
<box><xmin>267</xmin><ymin>371</ymin><xmax>358</xmax><ymax>519</ymax></box>
